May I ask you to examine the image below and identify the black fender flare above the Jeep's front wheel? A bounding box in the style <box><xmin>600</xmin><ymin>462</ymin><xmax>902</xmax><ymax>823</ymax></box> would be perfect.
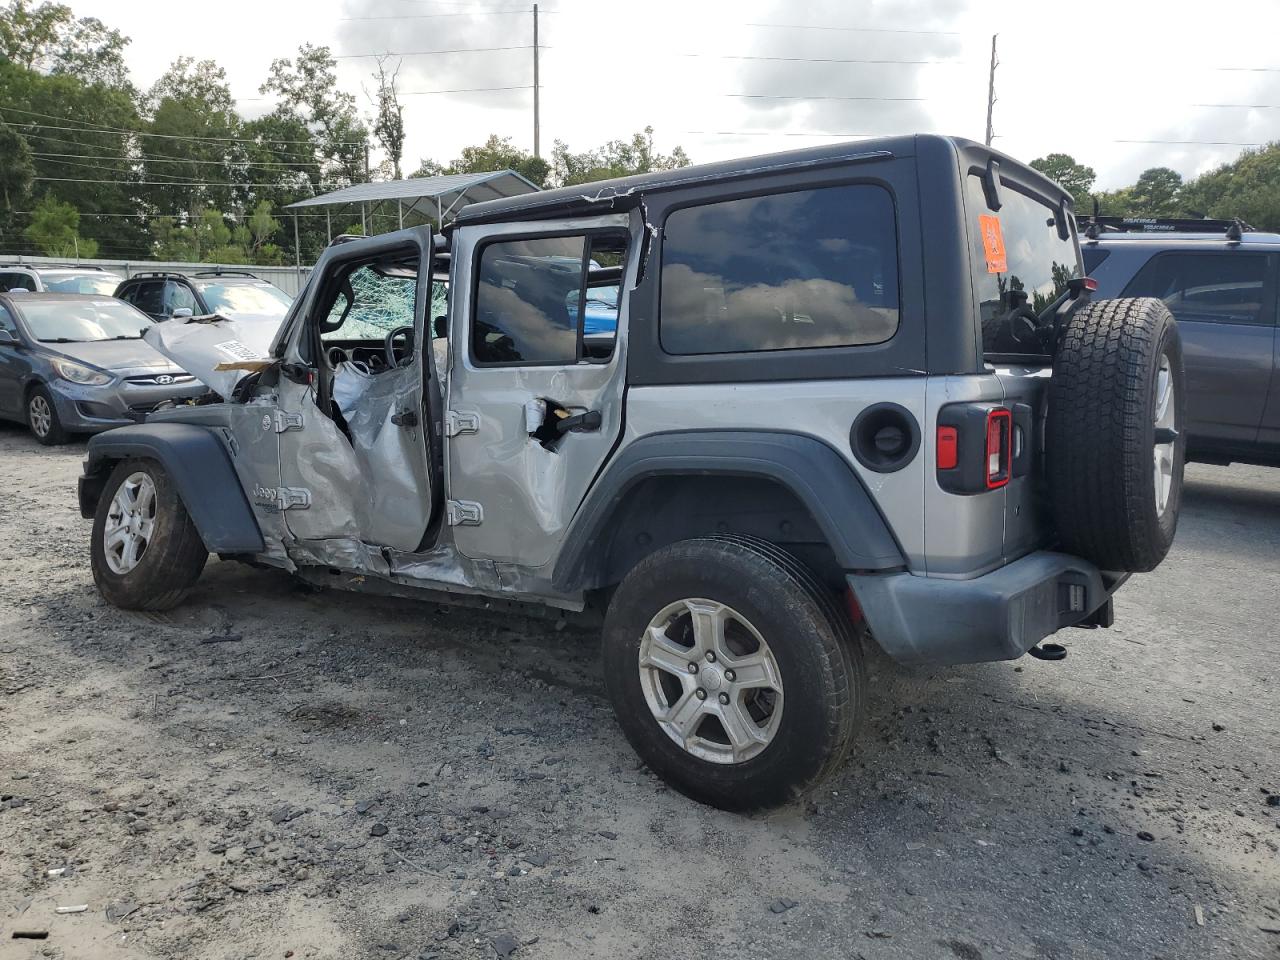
<box><xmin>79</xmin><ymin>424</ymin><xmax>265</xmax><ymax>554</ymax></box>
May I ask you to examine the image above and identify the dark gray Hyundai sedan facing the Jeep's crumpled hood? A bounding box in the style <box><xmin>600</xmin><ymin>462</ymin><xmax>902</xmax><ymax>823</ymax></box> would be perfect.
<box><xmin>0</xmin><ymin>292</ymin><xmax>209</xmax><ymax>444</ymax></box>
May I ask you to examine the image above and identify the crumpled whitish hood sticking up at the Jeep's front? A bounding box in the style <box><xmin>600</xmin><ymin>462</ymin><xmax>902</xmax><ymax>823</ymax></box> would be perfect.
<box><xmin>142</xmin><ymin>314</ymin><xmax>279</xmax><ymax>399</ymax></box>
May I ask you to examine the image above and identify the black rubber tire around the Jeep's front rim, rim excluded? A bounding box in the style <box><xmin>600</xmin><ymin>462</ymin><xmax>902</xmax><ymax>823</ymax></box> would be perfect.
<box><xmin>91</xmin><ymin>460</ymin><xmax>209</xmax><ymax>611</ymax></box>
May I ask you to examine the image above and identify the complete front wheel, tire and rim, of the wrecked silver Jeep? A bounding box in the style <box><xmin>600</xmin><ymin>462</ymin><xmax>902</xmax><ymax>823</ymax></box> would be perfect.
<box><xmin>90</xmin><ymin>460</ymin><xmax>209</xmax><ymax>611</ymax></box>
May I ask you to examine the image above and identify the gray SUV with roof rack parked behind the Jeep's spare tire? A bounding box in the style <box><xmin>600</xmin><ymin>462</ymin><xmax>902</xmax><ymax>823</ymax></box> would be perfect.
<box><xmin>1084</xmin><ymin>218</ymin><xmax>1280</xmax><ymax>466</ymax></box>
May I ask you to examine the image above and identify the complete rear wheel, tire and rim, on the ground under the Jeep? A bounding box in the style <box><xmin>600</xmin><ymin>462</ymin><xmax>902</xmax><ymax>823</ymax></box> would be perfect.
<box><xmin>603</xmin><ymin>536</ymin><xmax>865</xmax><ymax>810</ymax></box>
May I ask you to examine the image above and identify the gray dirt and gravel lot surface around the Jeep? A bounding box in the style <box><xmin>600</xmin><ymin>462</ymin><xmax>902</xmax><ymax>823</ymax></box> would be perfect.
<box><xmin>0</xmin><ymin>428</ymin><xmax>1280</xmax><ymax>960</ymax></box>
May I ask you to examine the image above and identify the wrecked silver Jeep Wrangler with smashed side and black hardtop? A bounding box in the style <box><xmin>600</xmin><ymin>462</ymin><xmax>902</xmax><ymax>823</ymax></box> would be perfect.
<box><xmin>79</xmin><ymin>136</ymin><xmax>1184</xmax><ymax>809</ymax></box>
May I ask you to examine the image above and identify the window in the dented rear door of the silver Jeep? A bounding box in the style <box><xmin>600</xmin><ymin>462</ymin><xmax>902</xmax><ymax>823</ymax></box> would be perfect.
<box><xmin>471</xmin><ymin>233</ymin><xmax>627</xmax><ymax>366</ymax></box>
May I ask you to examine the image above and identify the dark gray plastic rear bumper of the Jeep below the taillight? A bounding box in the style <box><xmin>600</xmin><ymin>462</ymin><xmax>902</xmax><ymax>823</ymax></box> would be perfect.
<box><xmin>849</xmin><ymin>550</ymin><xmax>1123</xmax><ymax>664</ymax></box>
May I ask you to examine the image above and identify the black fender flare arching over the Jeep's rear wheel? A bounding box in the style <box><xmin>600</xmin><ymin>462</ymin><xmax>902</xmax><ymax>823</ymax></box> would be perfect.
<box><xmin>552</xmin><ymin>430</ymin><xmax>906</xmax><ymax>591</ymax></box>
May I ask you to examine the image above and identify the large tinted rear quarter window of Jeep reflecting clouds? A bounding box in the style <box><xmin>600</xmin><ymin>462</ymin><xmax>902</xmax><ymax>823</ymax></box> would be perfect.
<box><xmin>659</xmin><ymin>184</ymin><xmax>899</xmax><ymax>355</ymax></box>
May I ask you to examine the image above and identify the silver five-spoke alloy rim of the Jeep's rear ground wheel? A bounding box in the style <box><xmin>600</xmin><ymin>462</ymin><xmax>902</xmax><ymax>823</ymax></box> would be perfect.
<box><xmin>637</xmin><ymin>599</ymin><xmax>782</xmax><ymax>764</ymax></box>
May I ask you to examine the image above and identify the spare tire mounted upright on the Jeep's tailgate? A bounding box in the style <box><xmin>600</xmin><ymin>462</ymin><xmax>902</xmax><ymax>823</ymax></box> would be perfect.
<box><xmin>1044</xmin><ymin>298</ymin><xmax>1187</xmax><ymax>572</ymax></box>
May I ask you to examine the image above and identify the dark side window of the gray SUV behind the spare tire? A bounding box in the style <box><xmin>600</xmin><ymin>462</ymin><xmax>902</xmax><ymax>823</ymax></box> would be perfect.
<box><xmin>1123</xmin><ymin>252</ymin><xmax>1272</xmax><ymax>325</ymax></box>
